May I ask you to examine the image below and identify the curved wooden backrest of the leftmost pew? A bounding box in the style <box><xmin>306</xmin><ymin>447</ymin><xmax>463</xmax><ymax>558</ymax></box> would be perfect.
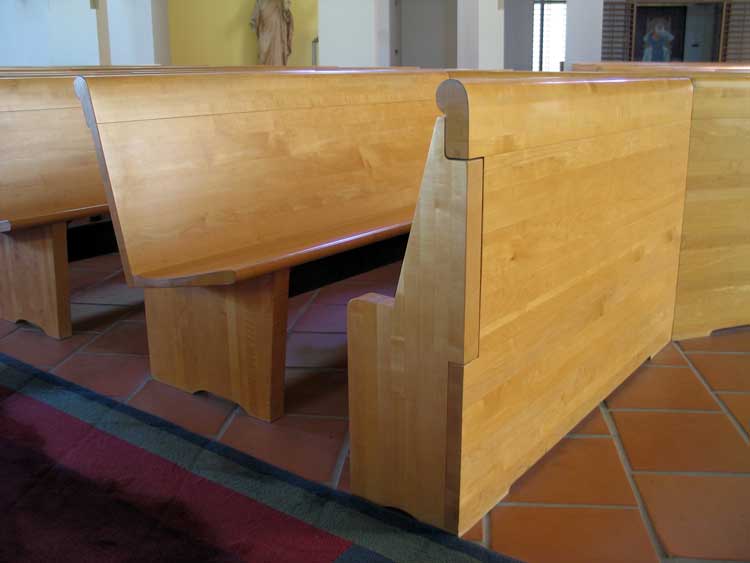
<box><xmin>0</xmin><ymin>77</ymin><xmax>107</xmax><ymax>231</ymax></box>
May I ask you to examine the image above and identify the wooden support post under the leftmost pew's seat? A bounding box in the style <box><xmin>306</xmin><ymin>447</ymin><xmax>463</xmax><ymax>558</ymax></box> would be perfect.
<box><xmin>0</xmin><ymin>222</ymin><xmax>73</xmax><ymax>338</ymax></box>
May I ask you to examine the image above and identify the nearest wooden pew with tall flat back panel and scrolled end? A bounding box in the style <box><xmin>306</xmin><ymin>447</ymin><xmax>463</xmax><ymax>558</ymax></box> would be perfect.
<box><xmin>348</xmin><ymin>77</ymin><xmax>692</xmax><ymax>534</ymax></box>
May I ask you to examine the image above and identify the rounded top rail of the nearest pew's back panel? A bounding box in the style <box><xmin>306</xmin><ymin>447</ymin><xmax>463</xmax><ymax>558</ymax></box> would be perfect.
<box><xmin>437</xmin><ymin>74</ymin><xmax>692</xmax><ymax>159</ymax></box>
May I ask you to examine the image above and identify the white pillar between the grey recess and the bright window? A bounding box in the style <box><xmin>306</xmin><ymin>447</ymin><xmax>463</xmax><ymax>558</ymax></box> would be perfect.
<box><xmin>457</xmin><ymin>0</ymin><xmax>504</xmax><ymax>70</ymax></box>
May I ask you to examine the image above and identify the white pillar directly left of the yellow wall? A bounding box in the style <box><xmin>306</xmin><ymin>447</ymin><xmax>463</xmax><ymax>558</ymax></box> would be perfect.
<box><xmin>106</xmin><ymin>0</ymin><xmax>169</xmax><ymax>65</ymax></box>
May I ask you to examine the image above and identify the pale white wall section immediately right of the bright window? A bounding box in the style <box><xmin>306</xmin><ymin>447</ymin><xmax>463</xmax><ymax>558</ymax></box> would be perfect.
<box><xmin>565</xmin><ymin>0</ymin><xmax>604</xmax><ymax>69</ymax></box>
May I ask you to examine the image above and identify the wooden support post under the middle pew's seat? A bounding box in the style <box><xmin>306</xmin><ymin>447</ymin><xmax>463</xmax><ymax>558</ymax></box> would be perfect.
<box><xmin>146</xmin><ymin>270</ymin><xmax>289</xmax><ymax>421</ymax></box>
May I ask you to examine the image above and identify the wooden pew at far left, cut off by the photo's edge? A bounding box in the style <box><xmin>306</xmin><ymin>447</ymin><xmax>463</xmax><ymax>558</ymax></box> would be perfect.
<box><xmin>0</xmin><ymin>66</ymin><xmax>400</xmax><ymax>338</ymax></box>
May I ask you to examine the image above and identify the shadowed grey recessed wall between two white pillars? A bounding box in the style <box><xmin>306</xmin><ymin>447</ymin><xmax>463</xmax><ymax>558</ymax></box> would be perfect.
<box><xmin>400</xmin><ymin>0</ymin><xmax>458</xmax><ymax>68</ymax></box>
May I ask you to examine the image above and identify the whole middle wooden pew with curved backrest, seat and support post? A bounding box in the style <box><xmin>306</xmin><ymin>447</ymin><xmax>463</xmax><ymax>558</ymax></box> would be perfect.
<box><xmin>77</xmin><ymin>71</ymin><xmax>447</xmax><ymax>420</ymax></box>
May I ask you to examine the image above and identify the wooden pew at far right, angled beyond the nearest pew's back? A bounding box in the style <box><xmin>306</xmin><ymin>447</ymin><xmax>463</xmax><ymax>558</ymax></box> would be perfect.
<box><xmin>576</xmin><ymin>63</ymin><xmax>750</xmax><ymax>339</ymax></box>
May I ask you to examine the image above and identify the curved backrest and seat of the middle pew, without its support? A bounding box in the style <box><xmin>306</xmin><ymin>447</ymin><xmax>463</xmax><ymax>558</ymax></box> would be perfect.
<box><xmin>76</xmin><ymin>70</ymin><xmax>447</xmax><ymax>287</ymax></box>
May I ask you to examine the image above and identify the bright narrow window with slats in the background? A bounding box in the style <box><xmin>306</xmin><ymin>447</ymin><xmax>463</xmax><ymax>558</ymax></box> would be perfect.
<box><xmin>532</xmin><ymin>0</ymin><xmax>568</xmax><ymax>72</ymax></box>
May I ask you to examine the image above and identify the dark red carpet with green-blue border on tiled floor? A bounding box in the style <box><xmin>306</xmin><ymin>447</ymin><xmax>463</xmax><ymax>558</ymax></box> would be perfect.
<box><xmin>0</xmin><ymin>355</ymin><xmax>524</xmax><ymax>563</ymax></box>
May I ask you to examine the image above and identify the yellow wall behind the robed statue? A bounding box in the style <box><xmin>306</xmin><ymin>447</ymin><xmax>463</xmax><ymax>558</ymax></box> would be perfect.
<box><xmin>169</xmin><ymin>0</ymin><xmax>318</xmax><ymax>66</ymax></box>
